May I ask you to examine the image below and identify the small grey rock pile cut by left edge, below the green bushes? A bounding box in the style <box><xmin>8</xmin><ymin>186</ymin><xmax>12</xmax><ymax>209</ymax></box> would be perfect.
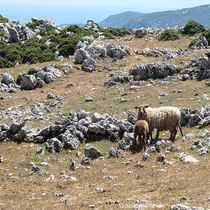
<box><xmin>0</xmin><ymin>73</ymin><xmax>18</xmax><ymax>93</ymax></box>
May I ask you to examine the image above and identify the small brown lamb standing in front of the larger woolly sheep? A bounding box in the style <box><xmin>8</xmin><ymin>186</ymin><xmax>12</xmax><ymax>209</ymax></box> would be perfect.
<box><xmin>134</xmin><ymin>120</ymin><xmax>149</xmax><ymax>151</ymax></box>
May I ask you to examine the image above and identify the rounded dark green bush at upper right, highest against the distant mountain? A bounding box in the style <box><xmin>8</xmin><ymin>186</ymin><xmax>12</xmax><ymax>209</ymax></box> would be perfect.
<box><xmin>182</xmin><ymin>21</ymin><xmax>206</xmax><ymax>36</ymax></box>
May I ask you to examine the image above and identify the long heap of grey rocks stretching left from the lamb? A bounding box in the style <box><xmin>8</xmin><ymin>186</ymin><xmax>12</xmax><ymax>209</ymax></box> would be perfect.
<box><xmin>34</xmin><ymin>110</ymin><xmax>133</xmax><ymax>152</ymax></box>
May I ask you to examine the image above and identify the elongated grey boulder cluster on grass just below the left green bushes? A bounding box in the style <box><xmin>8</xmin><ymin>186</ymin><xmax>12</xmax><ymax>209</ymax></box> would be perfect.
<box><xmin>17</xmin><ymin>66</ymin><xmax>62</xmax><ymax>90</ymax></box>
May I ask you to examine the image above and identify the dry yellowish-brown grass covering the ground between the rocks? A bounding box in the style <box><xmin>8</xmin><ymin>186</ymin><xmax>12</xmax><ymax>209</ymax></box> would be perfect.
<box><xmin>0</xmin><ymin>37</ymin><xmax>210</xmax><ymax>209</ymax></box>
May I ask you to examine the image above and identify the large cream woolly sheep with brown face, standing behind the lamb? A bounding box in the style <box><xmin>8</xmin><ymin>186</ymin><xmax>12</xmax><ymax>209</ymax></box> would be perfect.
<box><xmin>135</xmin><ymin>105</ymin><xmax>183</xmax><ymax>144</ymax></box>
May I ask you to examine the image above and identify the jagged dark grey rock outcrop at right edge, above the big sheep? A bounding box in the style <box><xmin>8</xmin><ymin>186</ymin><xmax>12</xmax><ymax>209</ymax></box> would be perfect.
<box><xmin>187</xmin><ymin>51</ymin><xmax>210</xmax><ymax>80</ymax></box>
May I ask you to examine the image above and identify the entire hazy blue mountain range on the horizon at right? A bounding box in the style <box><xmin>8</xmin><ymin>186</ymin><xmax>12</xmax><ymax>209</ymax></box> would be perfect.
<box><xmin>99</xmin><ymin>4</ymin><xmax>210</xmax><ymax>28</ymax></box>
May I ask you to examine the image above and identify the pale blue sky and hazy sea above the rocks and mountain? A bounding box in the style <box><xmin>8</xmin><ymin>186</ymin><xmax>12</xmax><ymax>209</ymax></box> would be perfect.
<box><xmin>0</xmin><ymin>0</ymin><xmax>210</xmax><ymax>25</ymax></box>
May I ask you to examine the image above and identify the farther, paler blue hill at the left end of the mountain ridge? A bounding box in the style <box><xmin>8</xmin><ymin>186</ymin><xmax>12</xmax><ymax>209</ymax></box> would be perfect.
<box><xmin>99</xmin><ymin>11</ymin><xmax>145</xmax><ymax>28</ymax></box>
